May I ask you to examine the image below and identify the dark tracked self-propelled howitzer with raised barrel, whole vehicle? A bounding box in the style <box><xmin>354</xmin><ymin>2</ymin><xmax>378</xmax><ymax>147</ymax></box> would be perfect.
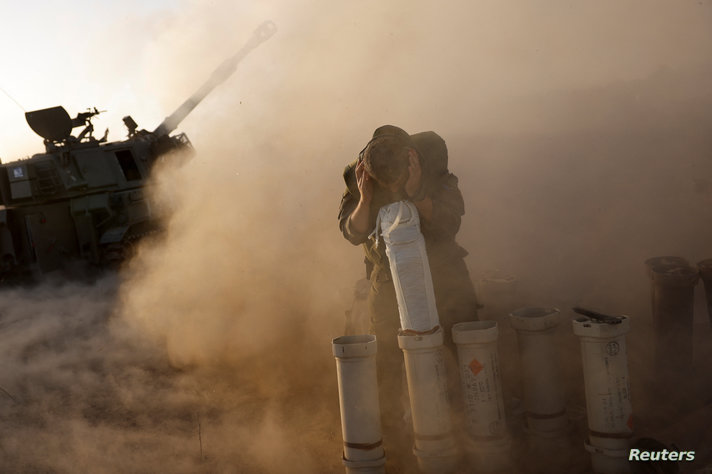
<box><xmin>0</xmin><ymin>22</ymin><xmax>276</xmax><ymax>280</ymax></box>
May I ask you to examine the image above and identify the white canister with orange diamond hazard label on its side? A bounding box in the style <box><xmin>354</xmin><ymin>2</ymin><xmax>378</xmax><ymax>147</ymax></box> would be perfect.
<box><xmin>452</xmin><ymin>321</ymin><xmax>512</xmax><ymax>472</ymax></box>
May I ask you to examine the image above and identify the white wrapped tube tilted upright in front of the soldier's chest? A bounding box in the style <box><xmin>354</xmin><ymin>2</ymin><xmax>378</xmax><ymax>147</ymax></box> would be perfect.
<box><xmin>376</xmin><ymin>201</ymin><xmax>440</xmax><ymax>332</ymax></box>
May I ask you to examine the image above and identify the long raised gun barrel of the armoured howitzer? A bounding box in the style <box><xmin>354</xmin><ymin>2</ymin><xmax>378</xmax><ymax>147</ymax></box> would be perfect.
<box><xmin>153</xmin><ymin>21</ymin><xmax>277</xmax><ymax>136</ymax></box>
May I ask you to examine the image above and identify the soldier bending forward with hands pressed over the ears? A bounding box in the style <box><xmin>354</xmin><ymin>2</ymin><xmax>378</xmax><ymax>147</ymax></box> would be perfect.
<box><xmin>339</xmin><ymin>125</ymin><xmax>477</xmax><ymax>462</ymax></box>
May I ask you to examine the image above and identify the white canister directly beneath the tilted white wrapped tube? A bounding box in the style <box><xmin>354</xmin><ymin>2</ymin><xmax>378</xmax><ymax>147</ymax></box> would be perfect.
<box><xmin>398</xmin><ymin>328</ymin><xmax>458</xmax><ymax>473</ymax></box>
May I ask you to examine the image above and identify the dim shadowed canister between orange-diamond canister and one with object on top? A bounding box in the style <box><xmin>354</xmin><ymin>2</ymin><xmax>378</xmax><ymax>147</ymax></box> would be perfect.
<box><xmin>509</xmin><ymin>307</ymin><xmax>569</xmax><ymax>435</ymax></box>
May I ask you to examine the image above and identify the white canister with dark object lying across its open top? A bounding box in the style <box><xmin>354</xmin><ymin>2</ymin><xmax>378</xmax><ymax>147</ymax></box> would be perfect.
<box><xmin>573</xmin><ymin>316</ymin><xmax>633</xmax><ymax>474</ymax></box>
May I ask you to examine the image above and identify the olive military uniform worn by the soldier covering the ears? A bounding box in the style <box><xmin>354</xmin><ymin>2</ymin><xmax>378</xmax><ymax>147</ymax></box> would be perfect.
<box><xmin>339</xmin><ymin>132</ymin><xmax>477</xmax><ymax>458</ymax></box>
